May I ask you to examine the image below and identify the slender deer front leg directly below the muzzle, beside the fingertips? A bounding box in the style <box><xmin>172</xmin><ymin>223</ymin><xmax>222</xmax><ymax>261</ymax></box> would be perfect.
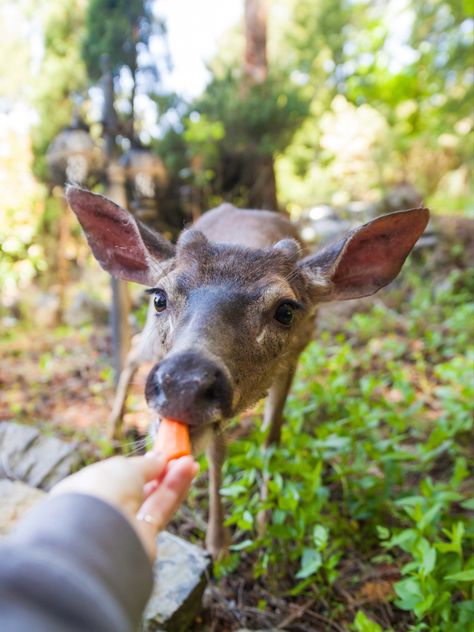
<box><xmin>206</xmin><ymin>434</ymin><xmax>229</xmax><ymax>559</ymax></box>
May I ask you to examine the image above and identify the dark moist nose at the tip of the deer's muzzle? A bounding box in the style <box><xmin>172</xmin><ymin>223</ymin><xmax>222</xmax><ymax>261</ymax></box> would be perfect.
<box><xmin>145</xmin><ymin>351</ymin><xmax>230</xmax><ymax>426</ymax></box>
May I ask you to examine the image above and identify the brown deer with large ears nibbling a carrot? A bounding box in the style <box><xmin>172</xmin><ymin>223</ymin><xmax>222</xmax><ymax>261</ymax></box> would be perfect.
<box><xmin>66</xmin><ymin>186</ymin><xmax>429</xmax><ymax>558</ymax></box>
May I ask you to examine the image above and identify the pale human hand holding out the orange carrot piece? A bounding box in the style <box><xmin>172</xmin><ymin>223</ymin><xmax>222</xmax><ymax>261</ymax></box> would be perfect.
<box><xmin>51</xmin><ymin>452</ymin><xmax>199</xmax><ymax>560</ymax></box>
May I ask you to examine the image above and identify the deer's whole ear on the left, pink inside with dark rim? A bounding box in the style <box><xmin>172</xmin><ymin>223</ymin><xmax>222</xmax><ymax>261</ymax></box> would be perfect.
<box><xmin>66</xmin><ymin>186</ymin><xmax>174</xmax><ymax>285</ymax></box>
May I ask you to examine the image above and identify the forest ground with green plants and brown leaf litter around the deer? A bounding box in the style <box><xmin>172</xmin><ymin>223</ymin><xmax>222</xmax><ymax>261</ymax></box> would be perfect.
<box><xmin>0</xmin><ymin>215</ymin><xmax>474</xmax><ymax>632</ymax></box>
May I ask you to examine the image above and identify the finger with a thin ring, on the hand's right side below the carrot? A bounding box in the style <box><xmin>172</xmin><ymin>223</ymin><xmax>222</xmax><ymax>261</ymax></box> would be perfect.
<box><xmin>138</xmin><ymin>457</ymin><xmax>199</xmax><ymax>532</ymax></box>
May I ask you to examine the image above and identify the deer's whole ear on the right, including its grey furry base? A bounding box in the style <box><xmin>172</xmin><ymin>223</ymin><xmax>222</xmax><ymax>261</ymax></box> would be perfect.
<box><xmin>299</xmin><ymin>208</ymin><xmax>429</xmax><ymax>301</ymax></box>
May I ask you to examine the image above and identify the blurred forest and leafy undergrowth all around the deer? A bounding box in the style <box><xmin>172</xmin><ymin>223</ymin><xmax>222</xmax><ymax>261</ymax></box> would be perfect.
<box><xmin>0</xmin><ymin>0</ymin><xmax>474</xmax><ymax>632</ymax></box>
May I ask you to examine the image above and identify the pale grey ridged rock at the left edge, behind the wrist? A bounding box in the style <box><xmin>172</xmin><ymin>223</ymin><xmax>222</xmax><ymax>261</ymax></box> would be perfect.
<box><xmin>0</xmin><ymin>422</ymin><xmax>82</xmax><ymax>491</ymax></box>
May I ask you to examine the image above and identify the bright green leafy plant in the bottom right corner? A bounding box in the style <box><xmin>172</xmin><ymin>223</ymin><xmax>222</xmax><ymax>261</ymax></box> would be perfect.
<box><xmin>379</xmin><ymin>478</ymin><xmax>474</xmax><ymax>632</ymax></box>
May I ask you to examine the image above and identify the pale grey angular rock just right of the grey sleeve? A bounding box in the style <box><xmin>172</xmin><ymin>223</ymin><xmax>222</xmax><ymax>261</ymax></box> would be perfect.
<box><xmin>143</xmin><ymin>531</ymin><xmax>211</xmax><ymax>632</ymax></box>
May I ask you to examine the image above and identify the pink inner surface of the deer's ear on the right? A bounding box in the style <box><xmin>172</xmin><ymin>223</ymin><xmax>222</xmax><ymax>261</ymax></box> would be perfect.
<box><xmin>332</xmin><ymin>209</ymin><xmax>428</xmax><ymax>298</ymax></box>
